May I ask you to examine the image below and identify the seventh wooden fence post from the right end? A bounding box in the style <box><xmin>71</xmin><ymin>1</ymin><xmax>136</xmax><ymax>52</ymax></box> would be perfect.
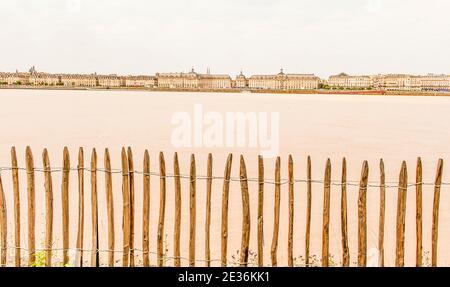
<box><xmin>322</xmin><ymin>159</ymin><xmax>331</xmax><ymax>267</ymax></box>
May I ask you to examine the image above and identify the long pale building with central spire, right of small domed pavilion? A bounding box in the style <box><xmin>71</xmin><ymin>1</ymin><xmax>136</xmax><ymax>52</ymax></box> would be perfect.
<box><xmin>248</xmin><ymin>69</ymin><xmax>320</xmax><ymax>90</ymax></box>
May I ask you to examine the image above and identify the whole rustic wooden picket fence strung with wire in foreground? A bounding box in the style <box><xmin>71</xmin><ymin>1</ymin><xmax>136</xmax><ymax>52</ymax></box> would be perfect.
<box><xmin>0</xmin><ymin>147</ymin><xmax>443</xmax><ymax>267</ymax></box>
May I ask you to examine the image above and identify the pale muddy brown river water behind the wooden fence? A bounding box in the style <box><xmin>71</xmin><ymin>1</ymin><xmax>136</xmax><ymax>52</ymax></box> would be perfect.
<box><xmin>0</xmin><ymin>90</ymin><xmax>450</xmax><ymax>266</ymax></box>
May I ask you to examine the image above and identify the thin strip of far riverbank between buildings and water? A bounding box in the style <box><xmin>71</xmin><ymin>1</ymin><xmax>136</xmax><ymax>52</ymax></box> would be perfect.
<box><xmin>0</xmin><ymin>86</ymin><xmax>450</xmax><ymax>97</ymax></box>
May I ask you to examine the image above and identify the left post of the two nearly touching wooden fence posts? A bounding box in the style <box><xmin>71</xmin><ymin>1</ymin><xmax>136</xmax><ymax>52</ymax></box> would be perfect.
<box><xmin>121</xmin><ymin>147</ymin><xmax>130</xmax><ymax>267</ymax></box>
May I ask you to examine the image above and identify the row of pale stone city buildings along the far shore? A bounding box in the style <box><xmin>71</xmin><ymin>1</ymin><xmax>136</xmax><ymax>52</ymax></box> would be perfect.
<box><xmin>0</xmin><ymin>66</ymin><xmax>450</xmax><ymax>92</ymax></box>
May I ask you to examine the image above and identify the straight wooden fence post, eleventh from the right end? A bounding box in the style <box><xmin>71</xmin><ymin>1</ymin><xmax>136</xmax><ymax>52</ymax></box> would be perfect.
<box><xmin>258</xmin><ymin>156</ymin><xmax>264</xmax><ymax>267</ymax></box>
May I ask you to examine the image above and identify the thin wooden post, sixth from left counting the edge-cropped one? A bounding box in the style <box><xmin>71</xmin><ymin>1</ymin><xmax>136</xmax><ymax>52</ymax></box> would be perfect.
<box><xmin>75</xmin><ymin>147</ymin><xmax>84</xmax><ymax>267</ymax></box>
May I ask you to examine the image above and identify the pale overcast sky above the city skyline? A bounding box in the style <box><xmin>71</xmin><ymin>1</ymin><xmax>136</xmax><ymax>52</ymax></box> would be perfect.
<box><xmin>0</xmin><ymin>0</ymin><xmax>450</xmax><ymax>77</ymax></box>
